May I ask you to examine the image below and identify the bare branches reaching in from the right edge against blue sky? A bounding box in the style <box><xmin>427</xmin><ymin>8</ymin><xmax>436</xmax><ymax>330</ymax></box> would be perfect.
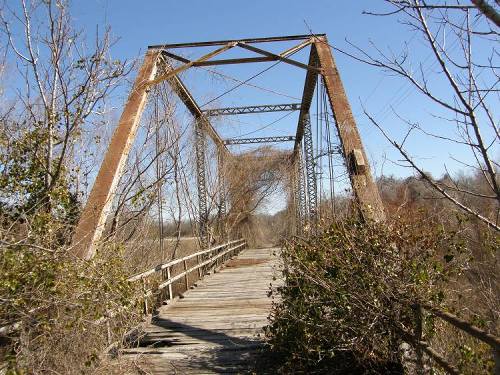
<box><xmin>347</xmin><ymin>0</ymin><xmax>500</xmax><ymax>231</ymax></box>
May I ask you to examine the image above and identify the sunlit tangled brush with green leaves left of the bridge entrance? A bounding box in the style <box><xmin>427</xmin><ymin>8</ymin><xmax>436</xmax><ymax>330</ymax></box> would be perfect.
<box><xmin>0</xmin><ymin>245</ymin><xmax>140</xmax><ymax>374</ymax></box>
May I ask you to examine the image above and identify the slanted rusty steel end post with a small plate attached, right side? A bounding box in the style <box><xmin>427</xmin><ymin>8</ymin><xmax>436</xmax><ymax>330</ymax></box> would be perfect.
<box><xmin>314</xmin><ymin>36</ymin><xmax>385</xmax><ymax>221</ymax></box>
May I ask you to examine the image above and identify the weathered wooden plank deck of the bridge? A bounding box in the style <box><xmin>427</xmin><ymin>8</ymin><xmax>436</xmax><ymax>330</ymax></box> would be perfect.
<box><xmin>124</xmin><ymin>249</ymin><xmax>279</xmax><ymax>374</ymax></box>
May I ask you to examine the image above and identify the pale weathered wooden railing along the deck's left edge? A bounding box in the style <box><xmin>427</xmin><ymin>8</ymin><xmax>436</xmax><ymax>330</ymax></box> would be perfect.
<box><xmin>128</xmin><ymin>239</ymin><xmax>247</xmax><ymax>312</ymax></box>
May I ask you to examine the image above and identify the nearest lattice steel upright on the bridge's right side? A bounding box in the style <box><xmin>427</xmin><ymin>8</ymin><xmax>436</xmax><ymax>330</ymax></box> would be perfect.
<box><xmin>303</xmin><ymin>113</ymin><xmax>318</xmax><ymax>225</ymax></box>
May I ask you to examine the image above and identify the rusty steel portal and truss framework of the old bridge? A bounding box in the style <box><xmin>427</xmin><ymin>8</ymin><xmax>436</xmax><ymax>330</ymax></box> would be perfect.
<box><xmin>71</xmin><ymin>34</ymin><xmax>385</xmax><ymax>259</ymax></box>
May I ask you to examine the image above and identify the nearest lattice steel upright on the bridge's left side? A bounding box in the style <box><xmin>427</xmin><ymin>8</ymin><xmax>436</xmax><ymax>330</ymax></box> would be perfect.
<box><xmin>195</xmin><ymin>120</ymin><xmax>208</xmax><ymax>249</ymax></box>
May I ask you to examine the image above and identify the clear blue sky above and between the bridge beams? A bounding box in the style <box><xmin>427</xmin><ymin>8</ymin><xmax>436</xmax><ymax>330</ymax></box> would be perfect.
<box><xmin>5</xmin><ymin>0</ymin><xmax>498</xmax><ymax>184</ymax></box>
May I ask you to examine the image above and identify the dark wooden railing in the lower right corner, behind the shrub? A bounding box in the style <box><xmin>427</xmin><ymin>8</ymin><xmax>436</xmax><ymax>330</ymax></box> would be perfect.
<box><xmin>405</xmin><ymin>304</ymin><xmax>500</xmax><ymax>375</ymax></box>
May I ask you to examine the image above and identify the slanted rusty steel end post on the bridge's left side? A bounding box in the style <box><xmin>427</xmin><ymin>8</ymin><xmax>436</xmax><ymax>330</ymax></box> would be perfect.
<box><xmin>71</xmin><ymin>51</ymin><xmax>158</xmax><ymax>259</ymax></box>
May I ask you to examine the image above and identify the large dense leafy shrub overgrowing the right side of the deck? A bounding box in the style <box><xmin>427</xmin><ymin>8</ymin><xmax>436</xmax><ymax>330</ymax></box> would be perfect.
<box><xmin>267</xmin><ymin>218</ymin><xmax>465</xmax><ymax>373</ymax></box>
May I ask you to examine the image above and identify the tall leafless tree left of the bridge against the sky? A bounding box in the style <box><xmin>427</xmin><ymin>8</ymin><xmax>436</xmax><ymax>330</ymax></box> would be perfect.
<box><xmin>0</xmin><ymin>0</ymin><xmax>129</xmax><ymax>217</ymax></box>
